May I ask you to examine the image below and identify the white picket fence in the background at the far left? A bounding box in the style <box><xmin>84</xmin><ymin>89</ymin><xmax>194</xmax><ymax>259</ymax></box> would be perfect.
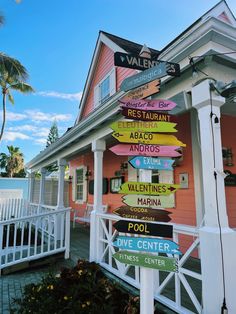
<box><xmin>0</xmin><ymin>198</ymin><xmax>28</xmax><ymax>221</ymax></box>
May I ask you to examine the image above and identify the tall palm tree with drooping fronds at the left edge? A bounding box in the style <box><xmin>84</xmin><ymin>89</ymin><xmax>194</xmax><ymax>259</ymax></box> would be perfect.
<box><xmin>0</xmin><ymin>53</ymin><xmax>34</xmax><ymax>141</ymax></box>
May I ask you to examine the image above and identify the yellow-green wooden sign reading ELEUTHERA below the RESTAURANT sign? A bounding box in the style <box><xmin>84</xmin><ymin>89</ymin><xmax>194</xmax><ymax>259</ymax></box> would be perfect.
<box><xmin>109</xmin><ymin>120</ymin><xmax>177</xmax><ymax>133</ymax></box>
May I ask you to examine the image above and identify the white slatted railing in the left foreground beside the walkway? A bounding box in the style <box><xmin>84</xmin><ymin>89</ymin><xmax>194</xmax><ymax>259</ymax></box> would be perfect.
<box><xmin>0</xmin><ymin>206</ymin><xmax>70</xmax><ymax>269</ymax></box>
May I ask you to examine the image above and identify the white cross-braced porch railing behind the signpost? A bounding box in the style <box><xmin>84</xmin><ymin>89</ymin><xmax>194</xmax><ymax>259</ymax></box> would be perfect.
<box><xmin>97</xmin><ymin>213</ymin><xmax>202</xmax><ymax>313</ymax></box>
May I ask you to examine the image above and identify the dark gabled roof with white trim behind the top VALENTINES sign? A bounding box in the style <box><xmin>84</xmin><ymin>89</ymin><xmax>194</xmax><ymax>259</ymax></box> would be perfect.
<box><xmin>76</xmin><ymin>31</ymin><xmax>159</xmax><ymax>123</ymax></box>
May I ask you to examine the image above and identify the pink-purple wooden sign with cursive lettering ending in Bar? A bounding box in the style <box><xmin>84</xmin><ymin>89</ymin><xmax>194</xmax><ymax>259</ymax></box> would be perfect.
<box><xmin>119</xmin><ymin>98</ymin><xmax>177</xmax><ymax>111</ymax></box>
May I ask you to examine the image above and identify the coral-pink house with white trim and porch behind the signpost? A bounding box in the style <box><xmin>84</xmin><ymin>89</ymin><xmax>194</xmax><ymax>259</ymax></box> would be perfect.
<box><xmin>28</xmin><ymin>1</ymin><xmax>236</xmax><ymax>314</ymax></box>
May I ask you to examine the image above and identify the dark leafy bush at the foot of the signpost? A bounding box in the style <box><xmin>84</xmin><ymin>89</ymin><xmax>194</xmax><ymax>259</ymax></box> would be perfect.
<box><xmin>12</xmin><ymin>260</ymin><xmax>139</xmax><ymax>314</ymax></box>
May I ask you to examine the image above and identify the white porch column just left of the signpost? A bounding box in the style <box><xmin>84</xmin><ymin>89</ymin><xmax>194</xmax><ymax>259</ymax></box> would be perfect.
<box><xmin>89</xmin><ymin>140</ymin><xmax>106</xmax><ymax>262</ymax></box>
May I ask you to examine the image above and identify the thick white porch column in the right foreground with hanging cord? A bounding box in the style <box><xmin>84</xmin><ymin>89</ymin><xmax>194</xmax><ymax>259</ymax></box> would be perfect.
<box><xmin>192</xmin><ymin>80</ymin><xmax>236</xmax><ymax>314</ymax></box>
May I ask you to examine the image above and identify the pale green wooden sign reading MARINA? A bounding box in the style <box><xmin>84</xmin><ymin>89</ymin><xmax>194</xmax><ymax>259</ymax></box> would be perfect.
<box><xmin>122</xmin><ymin>194</ymin><xmax>175</xmax><ymax>209</ymax></box>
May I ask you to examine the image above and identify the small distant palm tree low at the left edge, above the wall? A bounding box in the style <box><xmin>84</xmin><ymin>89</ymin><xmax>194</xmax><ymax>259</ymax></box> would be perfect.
<box><xmin>0</xmin><ymin>145</ymin><xmax>24</xmax><ymax>178</ymax></box>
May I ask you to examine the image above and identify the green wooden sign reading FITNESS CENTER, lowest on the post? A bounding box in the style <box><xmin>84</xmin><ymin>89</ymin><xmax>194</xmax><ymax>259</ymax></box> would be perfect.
<box><xmin>113</xmin><ymin>251</ymin><xmax>178</xmax><ymax>272</ymax></box>
